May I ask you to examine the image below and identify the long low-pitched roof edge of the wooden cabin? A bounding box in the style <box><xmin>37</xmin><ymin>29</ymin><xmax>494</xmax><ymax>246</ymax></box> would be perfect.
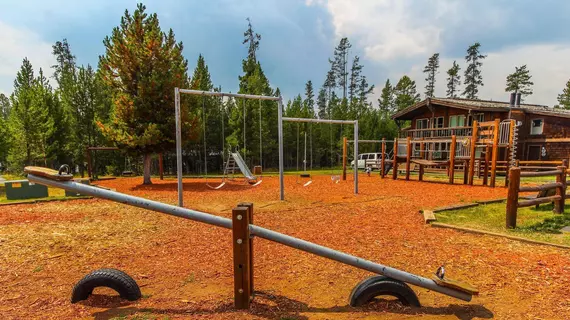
<box><xmin>392</xmin><ymin>98</ymin><xmax>570</xmax><ymax>120</ymax></box>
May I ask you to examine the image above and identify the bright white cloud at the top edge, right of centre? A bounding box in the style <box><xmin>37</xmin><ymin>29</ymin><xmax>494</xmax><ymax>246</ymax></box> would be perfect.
<box><xmin>305</xmin><ymin>0</ymin><xmax>455</xmax><ymax>61</ymax></box>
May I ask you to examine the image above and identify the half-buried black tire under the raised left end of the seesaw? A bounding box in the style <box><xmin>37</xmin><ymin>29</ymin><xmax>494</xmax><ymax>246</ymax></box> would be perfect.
<box><xmin>71</xmin><ymin>269</ymin><xmax>141</xmax><ymax>303</ymax></box>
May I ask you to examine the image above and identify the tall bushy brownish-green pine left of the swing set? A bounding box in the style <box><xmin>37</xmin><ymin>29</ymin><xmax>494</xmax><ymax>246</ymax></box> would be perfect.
<box><xmin>99</xmin><ymin>4</ymin><xmax>188</xmax><ymax>184</ymax></box>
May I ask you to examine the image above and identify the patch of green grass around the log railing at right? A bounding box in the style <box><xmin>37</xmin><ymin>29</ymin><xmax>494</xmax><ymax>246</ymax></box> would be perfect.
<box><xmin>436</xmin><ymin>203</ymin><xmax>570</xmax><ymax>245</ymax></box>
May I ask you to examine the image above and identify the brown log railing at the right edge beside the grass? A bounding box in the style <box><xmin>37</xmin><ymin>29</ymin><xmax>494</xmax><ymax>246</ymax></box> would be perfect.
<box><xmin>506</xmin><ymin>166</ymin><xmax>566</xmax><ymax>229</ymax></box>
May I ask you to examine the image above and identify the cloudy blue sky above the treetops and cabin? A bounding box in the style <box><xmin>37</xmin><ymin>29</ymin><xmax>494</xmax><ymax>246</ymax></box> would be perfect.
<box><xmin>0</xmin><ymin>0</ymin><xmax>570</xmax><ymax>106</ymax></box>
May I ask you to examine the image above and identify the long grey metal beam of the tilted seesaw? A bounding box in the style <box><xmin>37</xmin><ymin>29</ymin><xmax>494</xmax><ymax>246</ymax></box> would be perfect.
<box><xmin>28</xmin><ymin>174</ymin><xmax>471</xmax><ymax>301</ymax></box>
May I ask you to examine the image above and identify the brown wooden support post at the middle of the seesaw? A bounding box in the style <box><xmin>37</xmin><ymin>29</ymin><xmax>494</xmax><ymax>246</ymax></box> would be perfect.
<box><xmin>232</xmin><ymin>207</ymin><xmax>252</xmax><ymax>309</ymax></box>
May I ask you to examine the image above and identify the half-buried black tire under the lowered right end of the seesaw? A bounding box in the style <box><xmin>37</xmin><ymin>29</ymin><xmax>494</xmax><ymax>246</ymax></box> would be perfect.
<box><xmin>349</xmin><ymin>276</ymin><xmax>421</xmax><ymax>307</ymax></box>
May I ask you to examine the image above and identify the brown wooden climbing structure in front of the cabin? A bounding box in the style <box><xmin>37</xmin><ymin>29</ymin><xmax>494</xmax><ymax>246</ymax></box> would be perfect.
<box><xmin>372</xmin><ymin>119</ymin><xmax>517</xmax><ymax>187</ymax></box>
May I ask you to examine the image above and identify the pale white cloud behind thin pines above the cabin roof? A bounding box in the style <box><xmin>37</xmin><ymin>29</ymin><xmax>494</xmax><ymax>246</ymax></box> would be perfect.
<box><xmin>389</xmin><ymin>44</ymin><xmax>570</xmax><ymax>106</ymax></box>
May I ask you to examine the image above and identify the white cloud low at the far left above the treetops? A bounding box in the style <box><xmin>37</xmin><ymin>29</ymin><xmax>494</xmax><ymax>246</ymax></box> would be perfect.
<box><xmin>0</xmin><ymin>20</ymin><xmax>55</xmax><ymax>95</ymax></box>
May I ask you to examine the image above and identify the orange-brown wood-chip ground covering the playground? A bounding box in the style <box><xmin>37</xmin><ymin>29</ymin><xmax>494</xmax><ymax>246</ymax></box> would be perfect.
<box><xmin>0</xmin><ymin>175</ymin><xmax>570</xmax><ymax>320</ymax></box>
